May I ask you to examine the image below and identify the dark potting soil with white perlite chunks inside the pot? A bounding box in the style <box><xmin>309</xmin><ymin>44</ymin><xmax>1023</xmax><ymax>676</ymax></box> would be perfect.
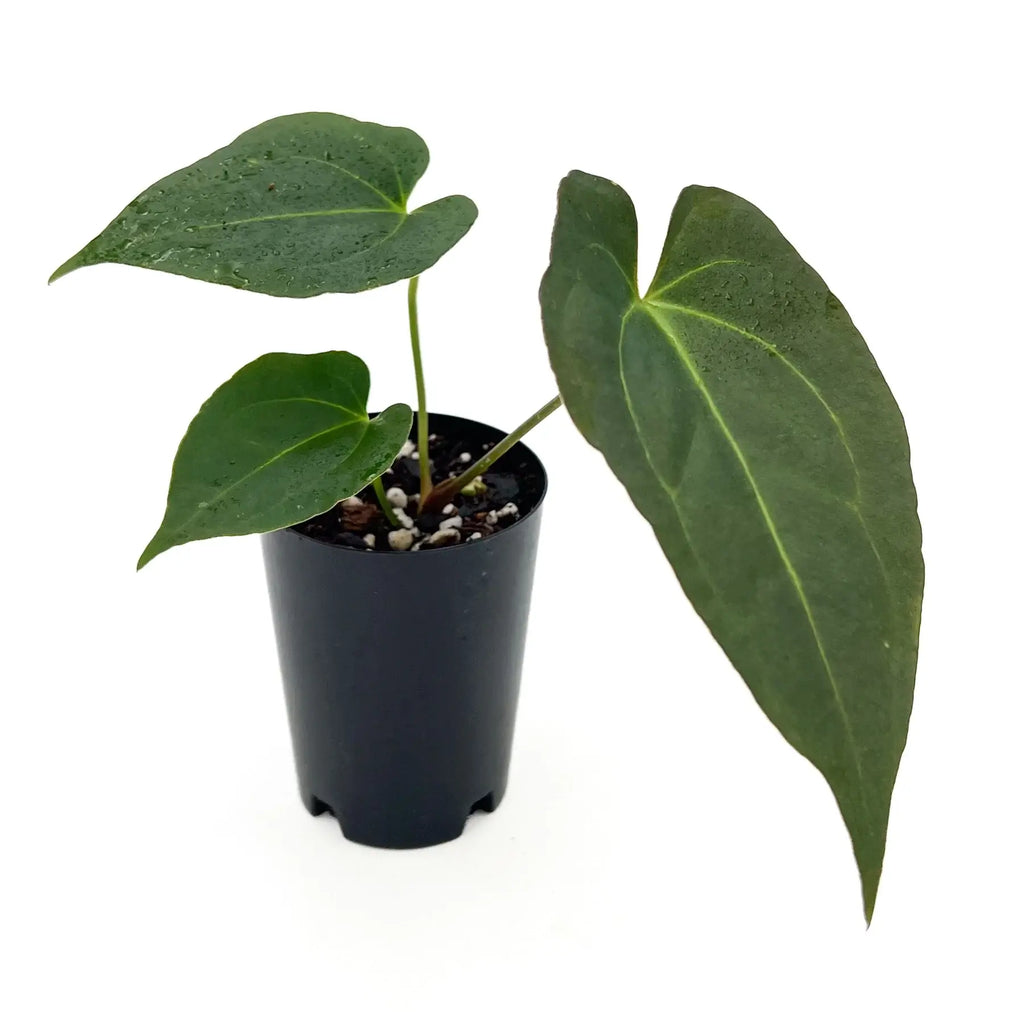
<box><xmin>292</xmin><ymin>425</ymin><xmax>544</xmax><ymax>552</ymax></box>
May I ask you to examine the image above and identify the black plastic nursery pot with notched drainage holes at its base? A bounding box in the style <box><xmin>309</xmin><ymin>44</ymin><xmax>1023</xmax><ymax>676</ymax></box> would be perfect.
<box><xmin>262</xmin><ymin>415</ymin><xmax>546</xmax><ymax>849</ymax></box>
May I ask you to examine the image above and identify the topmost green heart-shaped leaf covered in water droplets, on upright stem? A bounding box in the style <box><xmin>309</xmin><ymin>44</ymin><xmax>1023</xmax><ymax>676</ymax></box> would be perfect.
<box><xmin>50</xmin><ymin>114</ymin><xmax>476</xmax><ymax>298</ymax></box>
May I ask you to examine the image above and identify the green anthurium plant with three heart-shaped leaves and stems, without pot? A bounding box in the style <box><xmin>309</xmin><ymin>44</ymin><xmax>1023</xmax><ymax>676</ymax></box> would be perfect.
<box><xmin>51</xmin><ymin>114</ymin><xmax>924</xmax><ymax>921</ymax></box>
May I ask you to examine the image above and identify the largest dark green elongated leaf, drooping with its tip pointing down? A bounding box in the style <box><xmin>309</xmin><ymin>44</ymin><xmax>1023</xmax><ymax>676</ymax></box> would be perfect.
<box><xmin>541</xmin><ymin>172</ymin><xmax>924</xmax><ymax>921</ymax></box>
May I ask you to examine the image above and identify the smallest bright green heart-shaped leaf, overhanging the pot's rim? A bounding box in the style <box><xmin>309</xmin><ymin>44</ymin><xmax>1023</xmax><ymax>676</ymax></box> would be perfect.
<box><xmin>138</xmin><ymin>352</ymin><xmax>413</xmax><ymax>568</ymax></box>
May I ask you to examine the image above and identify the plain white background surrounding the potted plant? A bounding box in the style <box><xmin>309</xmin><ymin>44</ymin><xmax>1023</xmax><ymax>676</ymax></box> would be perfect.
<box><xmin>0</xmin><ymin>0</ymin><xmax>1024</xmax><ymax>1024</ymax></box>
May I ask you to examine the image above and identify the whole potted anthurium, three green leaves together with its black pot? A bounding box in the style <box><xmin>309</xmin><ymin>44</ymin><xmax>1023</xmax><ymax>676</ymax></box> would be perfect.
<box><xmin>51</xmin><ymin>114</ymin><xmax>924</xmax><ymax>920</ymax></box>
